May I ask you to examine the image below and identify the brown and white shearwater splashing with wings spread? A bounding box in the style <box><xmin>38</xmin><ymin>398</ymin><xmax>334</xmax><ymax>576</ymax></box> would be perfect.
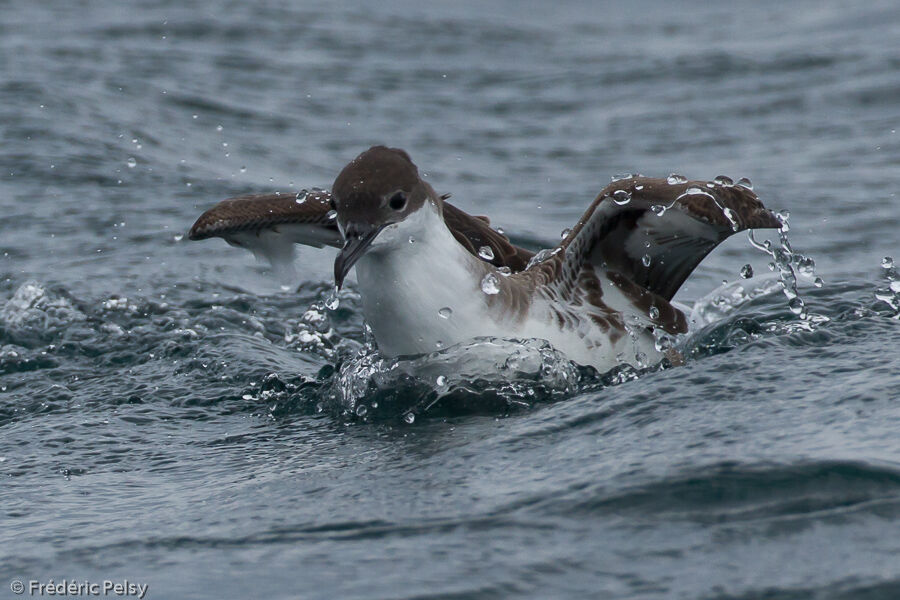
<box><xmin>189</xmin><ymin>146</ymin><xmax>781</xmax><ymax>371</ymax></box>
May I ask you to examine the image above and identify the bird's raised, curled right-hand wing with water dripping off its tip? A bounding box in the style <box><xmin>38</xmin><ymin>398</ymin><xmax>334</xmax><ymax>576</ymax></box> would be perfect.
<box><xmin>520</xmin><ymin>177</ymin><xmax>781</xmax><ymax>332</ymax></box>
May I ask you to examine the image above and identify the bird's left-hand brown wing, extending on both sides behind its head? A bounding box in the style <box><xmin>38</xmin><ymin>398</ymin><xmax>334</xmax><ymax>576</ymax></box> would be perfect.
<box><xmin>188</xmin><ymin>190</ymin><xmax>534</xmax><ymax>272</ymax></box>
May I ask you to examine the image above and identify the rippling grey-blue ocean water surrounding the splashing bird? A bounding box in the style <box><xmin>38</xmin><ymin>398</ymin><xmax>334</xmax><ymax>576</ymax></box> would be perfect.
<box><xmin>0</xmin><ymin>0</ymin><xmax>900</xmax><ymax>600</ymax></box>
